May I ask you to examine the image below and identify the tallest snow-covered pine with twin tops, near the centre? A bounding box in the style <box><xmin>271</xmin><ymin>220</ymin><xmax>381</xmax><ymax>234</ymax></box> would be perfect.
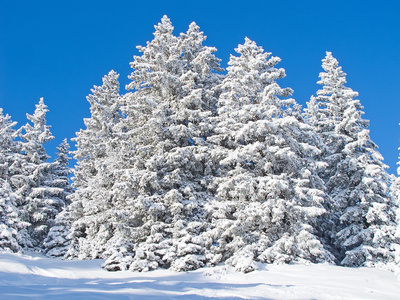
<box><xmin>101</xmin><ymin>16</ymin><xmax>221</xmax><ymax>270</ymax></box>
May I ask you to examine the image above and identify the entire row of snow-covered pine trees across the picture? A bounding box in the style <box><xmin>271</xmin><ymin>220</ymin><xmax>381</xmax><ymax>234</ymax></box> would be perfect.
<box><xmin>0</xmin><ymin>16</ymin><xmax>400</xmax><ymax>272</ymax></box>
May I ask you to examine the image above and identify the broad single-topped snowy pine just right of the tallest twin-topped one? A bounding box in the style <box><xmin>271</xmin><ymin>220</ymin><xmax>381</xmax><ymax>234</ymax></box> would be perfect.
<box><xmin>209</xmin><ymin>38</ymin><xmax>333</xmax><ymax>272</ymax></box>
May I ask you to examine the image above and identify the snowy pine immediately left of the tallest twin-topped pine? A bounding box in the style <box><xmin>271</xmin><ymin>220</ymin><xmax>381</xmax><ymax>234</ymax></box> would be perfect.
<box><xmin>66</xmin><ymin>71</ymin><xmax>126</xmax><ymax>259</ymax></box>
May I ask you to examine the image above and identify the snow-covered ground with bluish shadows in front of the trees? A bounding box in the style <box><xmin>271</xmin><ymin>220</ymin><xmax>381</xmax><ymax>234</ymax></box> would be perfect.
<box><xmin>0</xmin><ymin>253</ymin><xmax>400</xmax><ymax>300</ymax></box>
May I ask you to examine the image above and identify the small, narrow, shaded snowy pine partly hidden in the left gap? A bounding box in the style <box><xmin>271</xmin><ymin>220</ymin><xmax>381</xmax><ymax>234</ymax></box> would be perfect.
<box><xmin>44</xmin><ymin>139</ymin><xmax>73</xmax><ymax>257</ymax></box>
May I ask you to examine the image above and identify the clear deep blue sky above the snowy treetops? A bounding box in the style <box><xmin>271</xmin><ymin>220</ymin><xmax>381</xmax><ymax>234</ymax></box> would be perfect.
<box><xmin>0</xmin><ymin>0</ymin><xmax>400</xmax><ymax>173</ymax></box>
